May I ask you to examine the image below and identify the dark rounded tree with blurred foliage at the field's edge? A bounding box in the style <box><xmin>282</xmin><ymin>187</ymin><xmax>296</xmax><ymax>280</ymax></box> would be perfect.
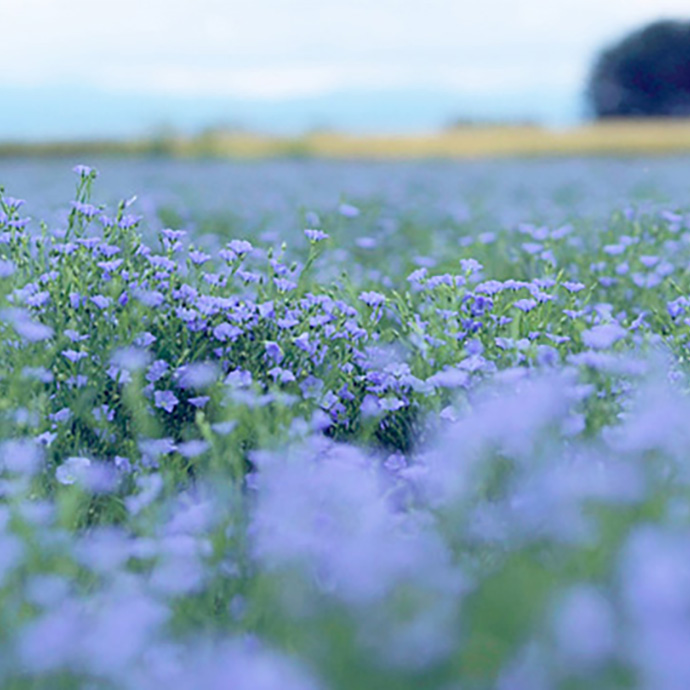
<box><xmin>587</xmin><ymin>21</ymin><xmax>690</xmax><ymax>118</ymax></box>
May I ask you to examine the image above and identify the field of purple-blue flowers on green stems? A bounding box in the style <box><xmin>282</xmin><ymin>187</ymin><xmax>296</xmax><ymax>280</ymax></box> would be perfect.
<box><xmin>0</xmin><ymin>158</ymin><xmax>690</xmax><ymax>690</ymax></box>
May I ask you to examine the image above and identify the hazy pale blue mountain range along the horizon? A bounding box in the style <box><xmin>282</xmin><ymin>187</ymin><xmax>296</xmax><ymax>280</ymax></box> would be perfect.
<box><xmin>0</xmin><ymin>86</ymin><xmax>581</xmax><ymax>141</ymax></box>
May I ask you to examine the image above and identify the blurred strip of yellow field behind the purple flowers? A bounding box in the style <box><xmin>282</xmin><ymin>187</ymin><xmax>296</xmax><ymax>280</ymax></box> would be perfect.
<box><xmin>6</xmin><ymin>119</ymin><xmax>690</xmax><ymax>159</ymax></box>
